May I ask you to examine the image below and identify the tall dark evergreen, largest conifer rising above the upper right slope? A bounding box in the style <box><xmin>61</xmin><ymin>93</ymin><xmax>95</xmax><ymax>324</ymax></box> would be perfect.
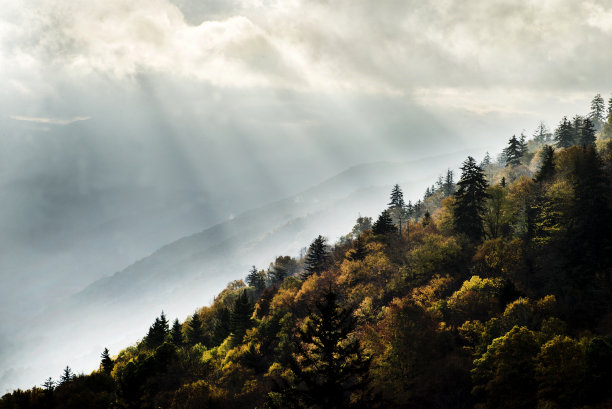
<box><xmin>453</xmin><ymin>156</ymin><xmax>487</xmax><ymax>242</ymax></box>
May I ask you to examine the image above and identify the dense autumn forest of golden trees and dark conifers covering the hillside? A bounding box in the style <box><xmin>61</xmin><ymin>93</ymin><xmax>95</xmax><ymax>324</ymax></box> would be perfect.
<box><xmin>0</xmin><ymin>95</ymin><xmax>612</xmax><ymax>409</ymax></box>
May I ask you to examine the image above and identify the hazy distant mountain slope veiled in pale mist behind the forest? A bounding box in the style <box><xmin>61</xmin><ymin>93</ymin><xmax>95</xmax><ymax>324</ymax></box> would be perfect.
<box><xmin>0</xmin><ymin>155</ymin><xmax>462</xmax><ymax>389</ymax></box>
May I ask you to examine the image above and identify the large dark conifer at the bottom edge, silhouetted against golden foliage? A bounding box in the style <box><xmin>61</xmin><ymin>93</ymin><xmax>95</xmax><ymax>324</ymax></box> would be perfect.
<box><xmin>285</xmin><ymin>289</ymin><xmax>370</xmax><ymax>409</ymax></box>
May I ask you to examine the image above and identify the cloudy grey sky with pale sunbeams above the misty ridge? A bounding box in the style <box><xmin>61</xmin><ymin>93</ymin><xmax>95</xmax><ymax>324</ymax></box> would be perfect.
<box><xmin>0</xmin><ymin>0</ymin><xmax>612</xmax><ymax>389</ymax></box>
